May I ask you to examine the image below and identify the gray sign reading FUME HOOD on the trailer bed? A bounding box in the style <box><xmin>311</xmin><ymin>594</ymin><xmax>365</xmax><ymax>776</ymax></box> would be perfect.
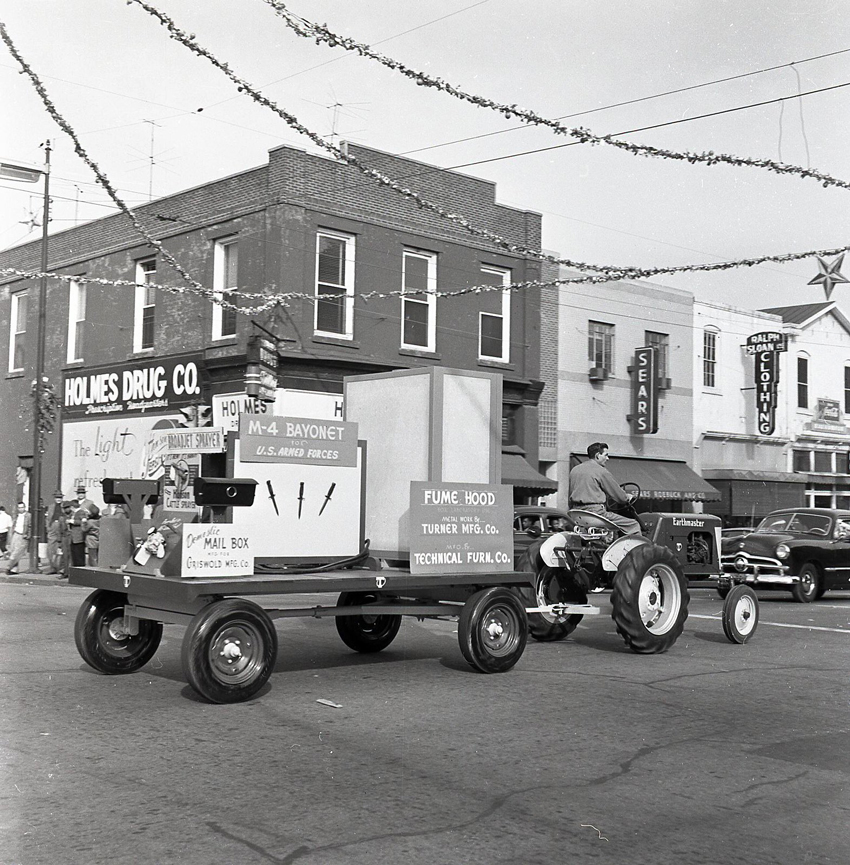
<box><xmin>410</xmin><ymin>481</ymin><xmax>513</xmax><ymax>574</ymax></box>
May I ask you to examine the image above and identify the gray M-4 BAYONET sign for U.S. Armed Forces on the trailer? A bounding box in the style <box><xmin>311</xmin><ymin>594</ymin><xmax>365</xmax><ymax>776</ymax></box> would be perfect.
<box><xmin>239</xmin><ymin>414</ymin><xmax>357</xmax><ymax>466</ymax></box>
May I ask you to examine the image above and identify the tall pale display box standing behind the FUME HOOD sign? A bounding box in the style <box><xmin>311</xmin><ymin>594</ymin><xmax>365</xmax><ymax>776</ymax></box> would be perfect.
<box><xmin>344</xmin><ymin>367</ymin><xmax>502</xmax><ymax>559</ymax></box>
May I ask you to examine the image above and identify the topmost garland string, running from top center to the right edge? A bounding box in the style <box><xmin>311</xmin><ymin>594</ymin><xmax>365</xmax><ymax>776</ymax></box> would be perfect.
<box><xmin>264</xmin><ymin>0</ymin><xmax>850</xmax><ymax>189</ymax></box>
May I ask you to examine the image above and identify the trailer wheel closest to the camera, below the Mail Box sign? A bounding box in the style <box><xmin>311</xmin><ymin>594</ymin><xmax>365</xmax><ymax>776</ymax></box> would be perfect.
<box><xmin>182</xmin><ymin>598</ymin><xmax>277</xmax><ymax>703</ymax></box>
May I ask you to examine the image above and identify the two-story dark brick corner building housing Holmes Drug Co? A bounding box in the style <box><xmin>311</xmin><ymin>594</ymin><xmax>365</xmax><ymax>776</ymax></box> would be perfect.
<box><xmin>0</xmin><ymin>145</ymin><xmax>552</xmax><ymax>520</ymax></box>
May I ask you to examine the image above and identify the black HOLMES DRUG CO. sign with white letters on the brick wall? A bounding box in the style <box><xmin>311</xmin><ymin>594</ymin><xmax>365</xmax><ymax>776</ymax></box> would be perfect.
<box><xmin>62</xmin><ymin>354</ymin><xmax>202</xmax><ymax>420</ymax></box>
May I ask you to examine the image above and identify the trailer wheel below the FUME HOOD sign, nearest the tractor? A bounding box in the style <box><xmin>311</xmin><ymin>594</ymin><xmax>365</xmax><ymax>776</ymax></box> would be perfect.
<box><xmin>457</xmin><ymin>586</ymin><xmax>528</xmax><ymax>673</ymax></box>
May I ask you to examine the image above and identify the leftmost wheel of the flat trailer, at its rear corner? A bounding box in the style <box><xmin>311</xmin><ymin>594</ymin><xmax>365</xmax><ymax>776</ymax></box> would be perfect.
<box><xmin>74</xmin><ymin>589</ymin><xmax>162</xmax><ymax>675</ymax></box>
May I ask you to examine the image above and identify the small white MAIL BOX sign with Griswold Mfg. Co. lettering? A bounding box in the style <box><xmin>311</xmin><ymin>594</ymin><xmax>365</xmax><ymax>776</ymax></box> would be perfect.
<box><xmin>180</xmin><ymin>523</ymin><xmax>254</xmax><ymax>577</ymax></box>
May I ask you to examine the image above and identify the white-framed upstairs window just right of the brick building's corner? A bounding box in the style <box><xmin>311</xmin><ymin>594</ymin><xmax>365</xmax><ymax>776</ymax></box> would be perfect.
<box><xmin>314</xmin><ymin>232</ymin><xmax>354</xmax><ymax>339</ymax></box>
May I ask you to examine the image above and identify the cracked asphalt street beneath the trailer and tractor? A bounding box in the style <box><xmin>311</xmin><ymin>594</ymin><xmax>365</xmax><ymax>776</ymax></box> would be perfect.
<box><xmin>0</xmin><ymin>579</ymin><xmax>850</xmax><ymax>865</ymax></box>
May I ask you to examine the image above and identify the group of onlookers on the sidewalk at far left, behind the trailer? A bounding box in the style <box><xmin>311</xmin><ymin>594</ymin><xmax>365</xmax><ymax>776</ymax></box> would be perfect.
<box><xmin>0</xmin><ymin>486</ymin><xmax>107</xmax><ymax>579</ymax></box>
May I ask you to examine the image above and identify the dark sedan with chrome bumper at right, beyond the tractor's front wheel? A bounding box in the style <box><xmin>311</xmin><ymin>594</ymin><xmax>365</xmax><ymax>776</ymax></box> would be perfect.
<box><xmin>718</xmin><ymin>508</ymin><xmax>850</xmax><ymax>604</ymax></box>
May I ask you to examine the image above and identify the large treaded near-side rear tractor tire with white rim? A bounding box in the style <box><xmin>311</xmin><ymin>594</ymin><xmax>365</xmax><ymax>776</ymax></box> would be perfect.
<box><xmin>611</xmin><ymin>544</ymin><xmax>689</xmax><ymax>654</ymax></box>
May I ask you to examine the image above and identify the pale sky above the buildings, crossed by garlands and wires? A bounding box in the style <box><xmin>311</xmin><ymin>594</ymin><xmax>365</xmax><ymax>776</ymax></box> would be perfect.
<box><xmin>0</xmin><ymin>0</ymin><xmax>850</xmax><ymax>312</ymax></box>
